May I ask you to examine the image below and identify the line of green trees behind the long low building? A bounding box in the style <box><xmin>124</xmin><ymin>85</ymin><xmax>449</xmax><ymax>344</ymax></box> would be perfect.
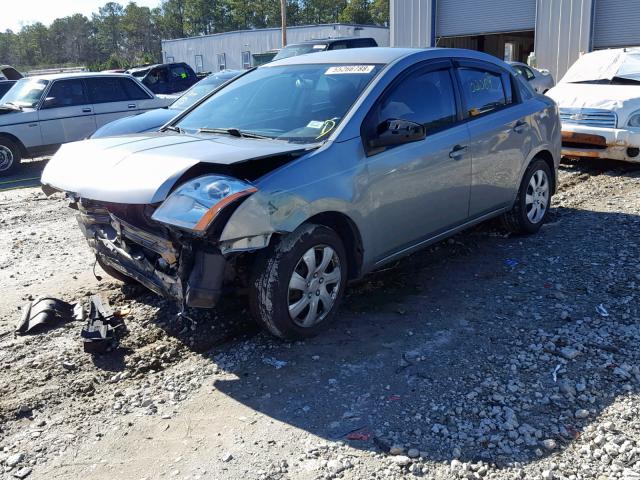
<box><xmin>0</xmin><ymin>0</ymin><xmax>389</xmax><ymax>70</ymax></box>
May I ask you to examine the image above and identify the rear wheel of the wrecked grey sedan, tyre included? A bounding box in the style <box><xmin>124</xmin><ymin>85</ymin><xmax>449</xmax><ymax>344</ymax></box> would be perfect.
<box><xmin>502</xmin><ymin>160</ymin><xmax>553</xmax><ymax>234</ymax></box>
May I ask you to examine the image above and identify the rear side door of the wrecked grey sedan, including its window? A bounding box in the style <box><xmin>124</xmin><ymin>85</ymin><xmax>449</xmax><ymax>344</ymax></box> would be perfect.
<box><xmin>456</xmin><ymin>60</ymin><xmax>531</xmax><ymax>217</ymax></box>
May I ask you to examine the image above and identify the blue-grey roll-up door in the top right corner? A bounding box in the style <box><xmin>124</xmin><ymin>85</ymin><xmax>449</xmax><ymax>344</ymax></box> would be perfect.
<box><xmin>593</xmin><ymin>0</ymin><xmax>640</xmax><ymax>48</ymax></box>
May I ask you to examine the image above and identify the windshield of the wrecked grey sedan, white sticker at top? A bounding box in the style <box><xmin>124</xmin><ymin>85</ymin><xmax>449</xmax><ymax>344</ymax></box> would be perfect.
<box><xmin>176</xmin><ymin>64</ymin><xmax>381</xmax><ymax>143</ymax></box>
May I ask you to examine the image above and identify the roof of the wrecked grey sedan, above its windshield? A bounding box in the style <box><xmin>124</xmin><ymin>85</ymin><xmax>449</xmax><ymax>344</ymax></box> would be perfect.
<box><xmin>258</xmin><ymin>47</ymin><xmax>504</xmax><ymax>68</ymax></box>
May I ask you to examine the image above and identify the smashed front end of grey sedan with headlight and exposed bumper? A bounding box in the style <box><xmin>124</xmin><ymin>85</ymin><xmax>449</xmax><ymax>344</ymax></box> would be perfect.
<box><xmin>71</xmin><ymin>175</ymin><xmax>271</xmax><ymax>308</ymax></box>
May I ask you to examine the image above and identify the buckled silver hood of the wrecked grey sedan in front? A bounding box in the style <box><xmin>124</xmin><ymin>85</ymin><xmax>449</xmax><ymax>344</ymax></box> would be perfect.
<box><xmin>41</xmin><ymin>133</ymin><xmax>306</xmax><ymax>204</ymax></box>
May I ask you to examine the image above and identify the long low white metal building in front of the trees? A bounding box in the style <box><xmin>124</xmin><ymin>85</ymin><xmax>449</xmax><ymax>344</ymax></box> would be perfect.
<box><xmin>162</xmin><ymin>23</ymin><xmax>389</xmax><ymax>72</ymax></box>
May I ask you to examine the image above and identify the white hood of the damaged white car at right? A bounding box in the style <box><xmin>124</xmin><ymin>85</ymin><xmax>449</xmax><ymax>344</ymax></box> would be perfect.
<box><xmin>546</xmin><ymin>83</ymin><xmax>640</xmax><ymax>120</ymax></box>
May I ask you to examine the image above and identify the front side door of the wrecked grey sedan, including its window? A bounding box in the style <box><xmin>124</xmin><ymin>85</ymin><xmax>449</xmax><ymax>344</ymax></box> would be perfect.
<box><xmin>365</xmin><ymin>61</ymin><xmax>471</xmax><ymax>260</ymax></box>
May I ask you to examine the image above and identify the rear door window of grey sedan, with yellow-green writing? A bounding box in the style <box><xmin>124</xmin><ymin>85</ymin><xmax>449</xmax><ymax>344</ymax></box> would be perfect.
<box><xmin>458</xmin><ymin>67</ymin><xmax>513</xmax><ymax>117</ymax></box>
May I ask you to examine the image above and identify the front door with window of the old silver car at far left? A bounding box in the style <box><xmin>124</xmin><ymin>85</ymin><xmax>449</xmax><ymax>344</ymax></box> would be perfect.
<box><xmin>38</xmin><ymin>78</ymin><xmax>96</xmax><ymax>145</ymax></box>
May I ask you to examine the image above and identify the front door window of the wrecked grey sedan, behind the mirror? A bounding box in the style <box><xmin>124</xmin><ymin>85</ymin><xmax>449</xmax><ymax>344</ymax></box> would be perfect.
<box><xmin>378</xmin><ymin>69</ymin><xmax>457</xmax><ymax>132</ymax></box>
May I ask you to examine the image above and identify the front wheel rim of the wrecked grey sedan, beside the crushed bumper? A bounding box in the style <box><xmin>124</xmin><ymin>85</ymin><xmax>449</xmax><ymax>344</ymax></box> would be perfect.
<box><xmin>288</xmin><ymin>245</ymin><xmax>342</xmax><ymax>328</ymax></box>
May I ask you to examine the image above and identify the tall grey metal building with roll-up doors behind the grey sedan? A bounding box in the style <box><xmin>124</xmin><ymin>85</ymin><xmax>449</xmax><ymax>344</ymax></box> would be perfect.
<box><xmin>390</xmin><ymin>0</ymin><xmax>640</xmax><ymax>79</ymax></box>
